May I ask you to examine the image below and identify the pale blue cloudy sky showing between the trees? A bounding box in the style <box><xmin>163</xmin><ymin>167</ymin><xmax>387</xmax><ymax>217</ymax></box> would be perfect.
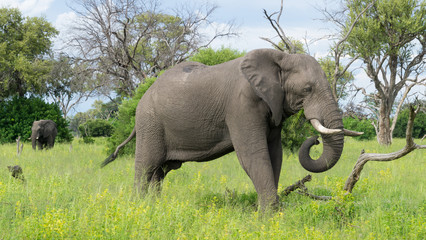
<box><xmin>0</xmin><ymin>0</ymin><xmax>380</xmax><ymax>111</ymax></box>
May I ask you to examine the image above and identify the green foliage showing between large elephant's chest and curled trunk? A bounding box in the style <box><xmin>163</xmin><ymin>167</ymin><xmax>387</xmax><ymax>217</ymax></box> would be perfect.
<box><xmin>281</xmin><ymin>110</ymin><xmax>314</xmax><ymax>153</ymax></box>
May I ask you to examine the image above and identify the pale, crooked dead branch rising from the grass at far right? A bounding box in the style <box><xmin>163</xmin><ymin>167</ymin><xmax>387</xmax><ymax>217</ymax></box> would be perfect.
<box><xmin>343</xmin><ymin>106</ymin><xmax>426</xmax><ymax>193</ymax></box>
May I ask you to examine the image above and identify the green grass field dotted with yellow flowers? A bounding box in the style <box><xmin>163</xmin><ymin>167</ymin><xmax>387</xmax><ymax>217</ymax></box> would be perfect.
<box><xmin>0</xmin><ymin>139</ymin><xmax>426</xmax><ymax>239</ymax></box>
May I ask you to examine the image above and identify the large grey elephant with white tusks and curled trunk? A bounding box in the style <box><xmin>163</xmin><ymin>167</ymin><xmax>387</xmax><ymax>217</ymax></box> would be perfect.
<box><xmin>102</xmin><ymin>49</ymin><xmax>362</xmax><ymax>210</ymax></box>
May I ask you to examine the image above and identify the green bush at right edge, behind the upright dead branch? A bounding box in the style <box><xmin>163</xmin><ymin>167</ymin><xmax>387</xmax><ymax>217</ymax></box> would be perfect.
<box><xmin>393</xmin><ymin>107</ymin><xmax>426</xmax><ymax>138</ymax></box>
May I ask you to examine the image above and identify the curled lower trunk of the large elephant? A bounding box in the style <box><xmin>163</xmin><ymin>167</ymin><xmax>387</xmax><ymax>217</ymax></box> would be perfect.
<box><xmin>299</xmin><ymin>111</ymin><xmax>344</xmax><ymax>173</ymax></box>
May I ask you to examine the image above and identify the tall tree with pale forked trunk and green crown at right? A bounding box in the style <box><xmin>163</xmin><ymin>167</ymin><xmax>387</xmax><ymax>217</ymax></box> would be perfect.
<box><xmin>345</xmin><ymin>0</ymin><xmax>426</xmax><ymax>145</ymax></box>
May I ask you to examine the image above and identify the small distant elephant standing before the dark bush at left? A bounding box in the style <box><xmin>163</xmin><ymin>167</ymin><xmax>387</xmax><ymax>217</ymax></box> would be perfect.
<box><xmin>31</xmin><ymin>120</ymin><xmax>58</xmax><ymax>150</ymax></box>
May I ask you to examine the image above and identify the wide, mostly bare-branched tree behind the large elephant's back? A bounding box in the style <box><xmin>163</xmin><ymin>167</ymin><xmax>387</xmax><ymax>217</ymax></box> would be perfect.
<box><xmin>69</xmin><ymin>0</ymin><xmax>235</xmax><ymax>97</ymax></box>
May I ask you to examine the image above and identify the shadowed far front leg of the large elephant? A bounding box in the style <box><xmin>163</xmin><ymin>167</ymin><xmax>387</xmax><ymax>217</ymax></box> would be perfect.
<box><xmin>268</xmin><ymin>125</ymin><xmax>283</xmax><ymax>188</ymax></box>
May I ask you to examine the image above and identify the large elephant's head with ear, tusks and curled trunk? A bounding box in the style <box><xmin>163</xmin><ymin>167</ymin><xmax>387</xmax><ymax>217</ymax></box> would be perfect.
<box><xmin>241</xmin><ymin>49</ymin><xmax>356</xmax><ymax>172</ymax></box>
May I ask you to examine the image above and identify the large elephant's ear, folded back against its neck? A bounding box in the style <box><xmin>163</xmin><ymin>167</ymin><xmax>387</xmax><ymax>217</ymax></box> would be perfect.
<box><xmin>240</xmin><ymin>49</ymin><xmax>285</xmax><ymax>126</ymax></box>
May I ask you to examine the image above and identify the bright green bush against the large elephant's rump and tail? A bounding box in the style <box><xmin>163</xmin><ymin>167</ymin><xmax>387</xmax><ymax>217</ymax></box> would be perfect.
<box><xmin>107</xmin><ymin>78</ymin><xmax>157</xmax><ymax>154</ymax></box>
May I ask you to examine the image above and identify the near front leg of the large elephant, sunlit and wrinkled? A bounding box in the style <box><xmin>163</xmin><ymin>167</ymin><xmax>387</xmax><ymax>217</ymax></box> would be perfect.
<box><xmin>230</xmin><ymin>124</ymin><xmax>279</xmax><ymax>211</ymax></box>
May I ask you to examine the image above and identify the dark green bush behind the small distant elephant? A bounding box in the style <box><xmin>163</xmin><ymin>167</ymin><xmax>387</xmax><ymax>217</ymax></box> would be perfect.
<box><xmin>0</xmin><ymin>97</ymin><xmax>73</xmax><ymax>143</ymax></box>
